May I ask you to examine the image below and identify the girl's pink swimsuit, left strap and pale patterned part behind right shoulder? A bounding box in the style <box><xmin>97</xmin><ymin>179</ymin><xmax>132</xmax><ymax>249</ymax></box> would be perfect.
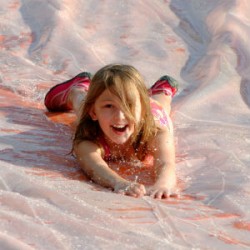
<box><xmin>99</xmin><ymin>98</ymin><xmax>169</xmax><ymax>161</ymax></box>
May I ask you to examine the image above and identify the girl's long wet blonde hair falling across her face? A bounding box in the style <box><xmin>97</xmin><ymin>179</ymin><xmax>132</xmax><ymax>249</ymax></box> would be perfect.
<box><xmin>73</xmin><ymin>64</ymin><xmax>157</xmax><ymax>160</ymax></box>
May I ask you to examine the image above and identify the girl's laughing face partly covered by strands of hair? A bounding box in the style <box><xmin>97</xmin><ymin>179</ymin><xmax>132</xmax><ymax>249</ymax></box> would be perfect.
<box><xmin>90</xmin><ymin>89</ymin><xmax>141</xmax><ymax>145</ymax></box>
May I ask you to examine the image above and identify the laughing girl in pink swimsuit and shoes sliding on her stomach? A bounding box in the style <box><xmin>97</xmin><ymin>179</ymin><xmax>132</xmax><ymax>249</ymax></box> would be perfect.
<box><xmin>45</xmin><ymin>64</ymin><xmax>177</xmax><ymax>198</ymax></box>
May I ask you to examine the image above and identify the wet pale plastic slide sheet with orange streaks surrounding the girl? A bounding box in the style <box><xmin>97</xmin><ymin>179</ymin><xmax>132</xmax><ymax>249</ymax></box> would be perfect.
<box><xmin>0</xmin><ymin>0</ymin><xmax>250</xmax><ymax>250</ymax></box>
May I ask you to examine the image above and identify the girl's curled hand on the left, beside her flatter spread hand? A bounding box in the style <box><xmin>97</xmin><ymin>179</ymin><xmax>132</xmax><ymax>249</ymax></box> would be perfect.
<box><xmin>114</xmin><ymin>181</ymin><xmax>146</xmax><ymax>197</ymax></box>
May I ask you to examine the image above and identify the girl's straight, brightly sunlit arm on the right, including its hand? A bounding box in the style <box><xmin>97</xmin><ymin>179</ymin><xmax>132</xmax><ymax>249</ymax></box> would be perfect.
<box><xmin>149</xmin><ymin>127</ymin><xmax>177</xmax><ymax>199</ymax></box>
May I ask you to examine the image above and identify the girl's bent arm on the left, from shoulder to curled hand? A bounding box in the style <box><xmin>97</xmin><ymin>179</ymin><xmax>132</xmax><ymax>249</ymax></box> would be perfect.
<box><xmin>74</xmin><ymin>141</ymin><xmax>146</xmax><ymax>197</ymax></box>
